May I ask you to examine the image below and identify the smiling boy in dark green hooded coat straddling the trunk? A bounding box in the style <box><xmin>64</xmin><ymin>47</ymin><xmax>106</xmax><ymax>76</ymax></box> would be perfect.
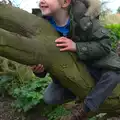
<box><xmin>32</xmin><ymin>0</ymin><xmax>120</xmax><ymax>120</ymax></box>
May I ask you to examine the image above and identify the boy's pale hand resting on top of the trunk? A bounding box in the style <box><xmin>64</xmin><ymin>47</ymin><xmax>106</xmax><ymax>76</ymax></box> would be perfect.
<box><xmin>55</xmin><ymin>37</ymin><xmax>76</xmax><ymax>52</ymax></box>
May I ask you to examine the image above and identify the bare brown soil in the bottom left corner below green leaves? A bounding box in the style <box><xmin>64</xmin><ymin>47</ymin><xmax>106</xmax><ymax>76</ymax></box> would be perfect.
<box><xmin>0</xmin><ymin>96</ymin><xmax>47</xmax><ymax>120</ymax></box>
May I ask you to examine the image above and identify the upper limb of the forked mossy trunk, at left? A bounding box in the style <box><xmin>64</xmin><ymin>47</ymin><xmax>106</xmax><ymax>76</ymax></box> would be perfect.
<box><xmin>0</xmin><ymin>4</ymin><xmax>56</xmax><ymax>37</ymax></box>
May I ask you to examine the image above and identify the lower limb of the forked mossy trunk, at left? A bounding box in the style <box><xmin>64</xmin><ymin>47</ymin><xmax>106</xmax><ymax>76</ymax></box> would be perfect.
<box><xmin>0</xmin><ymin>28</ymin><xmax>49</xmax><ymax>65</ymax></box>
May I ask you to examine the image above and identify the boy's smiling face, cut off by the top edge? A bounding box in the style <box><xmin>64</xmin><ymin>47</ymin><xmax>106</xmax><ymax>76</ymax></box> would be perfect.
<box><xmin>39</xmin><ymin>0</ymin><xmax>70</xmax><ymax>15</ymax></box>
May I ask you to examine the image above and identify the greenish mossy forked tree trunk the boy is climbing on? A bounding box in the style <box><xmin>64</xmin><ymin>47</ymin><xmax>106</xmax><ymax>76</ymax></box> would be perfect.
<box><xmin>0</xmin><ymin>4</ymin><xmax>120</xmax><ymax>114</ymax></box>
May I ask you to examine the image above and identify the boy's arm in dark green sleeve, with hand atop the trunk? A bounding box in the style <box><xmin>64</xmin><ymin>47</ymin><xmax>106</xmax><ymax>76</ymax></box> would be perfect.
<box><xmin>55</xmin><ymin>27</ymin><xmax>111</xmax><ymax>61</ymax></box>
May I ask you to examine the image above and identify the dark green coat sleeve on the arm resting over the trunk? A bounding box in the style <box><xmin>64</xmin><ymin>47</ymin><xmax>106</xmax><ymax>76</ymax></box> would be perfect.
<box><xmin>76</xmin><ymin>21</ymin><xmax>111</xmax><ymax>60</ymax></box>
